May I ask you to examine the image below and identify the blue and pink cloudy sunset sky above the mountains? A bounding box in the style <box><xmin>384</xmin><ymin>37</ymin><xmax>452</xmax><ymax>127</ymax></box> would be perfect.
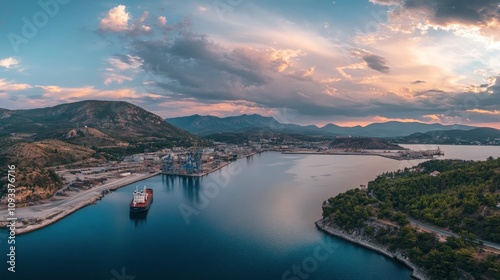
<box><xmin>0</xmin><ymin>0</ymin><xmax>500</xmax><ymax>128</ymax></box>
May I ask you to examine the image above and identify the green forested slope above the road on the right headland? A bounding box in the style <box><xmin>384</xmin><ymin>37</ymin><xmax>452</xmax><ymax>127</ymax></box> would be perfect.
<box><xmin>368</xmin><ymin>158</ymin><xmax>500</xmax><ymax>242</ymax></box>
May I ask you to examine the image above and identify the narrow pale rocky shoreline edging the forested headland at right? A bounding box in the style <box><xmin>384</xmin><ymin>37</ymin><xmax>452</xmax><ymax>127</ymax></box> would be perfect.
<box><xmin>314</xmin><ymin>219</ymin><xmax>428</xmax><ymax>280</ymax></box>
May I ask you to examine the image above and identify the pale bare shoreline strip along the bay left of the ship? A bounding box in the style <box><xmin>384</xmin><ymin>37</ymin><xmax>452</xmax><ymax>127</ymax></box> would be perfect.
<box><xmin>0</xmin><ymin>172</ymin><xmax>161</xmax><ymax>235</ymax></box>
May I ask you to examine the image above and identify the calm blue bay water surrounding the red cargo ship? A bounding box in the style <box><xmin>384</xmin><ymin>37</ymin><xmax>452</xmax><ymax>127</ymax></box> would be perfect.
<box><xmin>0</xmin><ymin>145</ymin><xmax>500</xmax><ymax>280</ymax></box>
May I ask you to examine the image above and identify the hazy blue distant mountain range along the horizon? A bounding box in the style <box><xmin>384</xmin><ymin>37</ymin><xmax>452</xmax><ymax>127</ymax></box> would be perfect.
<box><xmin>166</xmin><ymin>114</ymin><xmax>475</xmax><ymax>138</ymax></box>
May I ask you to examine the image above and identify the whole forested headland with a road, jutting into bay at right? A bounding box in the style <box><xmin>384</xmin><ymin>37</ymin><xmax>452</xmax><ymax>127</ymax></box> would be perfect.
<box><xmin>316</xmin><ymin>157</ymin><xmax>500</xmax><ymax>279</ymax></box>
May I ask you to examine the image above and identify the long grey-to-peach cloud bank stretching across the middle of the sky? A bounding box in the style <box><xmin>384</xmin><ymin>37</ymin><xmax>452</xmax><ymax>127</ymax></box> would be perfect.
<box><xmin>128</xmin><ymin>24</ymin><xmax>464</xmax><ymax>119</ymax></box>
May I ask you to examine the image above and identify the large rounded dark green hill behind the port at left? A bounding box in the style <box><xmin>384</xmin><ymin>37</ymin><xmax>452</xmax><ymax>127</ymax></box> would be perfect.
<box><xmin>0</xmin><ymin>100</ymin><xmax>194</xmax><ymax>146</ymax></box>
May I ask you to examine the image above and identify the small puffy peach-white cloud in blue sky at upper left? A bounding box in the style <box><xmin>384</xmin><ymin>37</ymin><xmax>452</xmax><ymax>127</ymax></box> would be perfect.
<box><xmin>99</xmin><ymin>5</ymin><xmax>151</xmax><ymax>36</ymax></box>
